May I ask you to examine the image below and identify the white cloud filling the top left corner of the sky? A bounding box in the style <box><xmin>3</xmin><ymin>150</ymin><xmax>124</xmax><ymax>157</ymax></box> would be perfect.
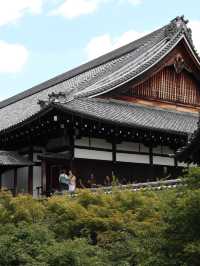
<box><xmin>0</xmin><ymin>0</ymin><xmax>43</xmax><ymax>26</ymax></box>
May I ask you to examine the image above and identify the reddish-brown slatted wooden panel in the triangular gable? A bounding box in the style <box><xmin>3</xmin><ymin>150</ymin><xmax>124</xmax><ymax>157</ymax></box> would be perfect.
<box><xmin>123</xmin><ymin>66</ymin><xmax>200</xmax><ymax>106</ymax></box>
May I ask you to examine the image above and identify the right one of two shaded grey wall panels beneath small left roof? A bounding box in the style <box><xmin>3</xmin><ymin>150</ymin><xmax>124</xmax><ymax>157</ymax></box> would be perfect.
<box><xmin>17</xmin><ymin>167</ymin><xmax>28</xmax><ymax>193</ymax></box>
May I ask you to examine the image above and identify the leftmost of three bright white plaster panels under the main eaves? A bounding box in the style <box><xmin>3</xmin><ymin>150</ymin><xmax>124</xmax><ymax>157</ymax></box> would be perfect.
<box><xmin>74</xmin><ymin>148</ymin><xmax>112</xmax><ymax>161</ymax></box>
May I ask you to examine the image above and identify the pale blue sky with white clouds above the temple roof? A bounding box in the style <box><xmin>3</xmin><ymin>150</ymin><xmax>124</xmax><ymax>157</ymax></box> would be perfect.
<box><xmin>0</xmin><ymin>0</ymin><xmax>200</xmax><ymax>100</ymax></box>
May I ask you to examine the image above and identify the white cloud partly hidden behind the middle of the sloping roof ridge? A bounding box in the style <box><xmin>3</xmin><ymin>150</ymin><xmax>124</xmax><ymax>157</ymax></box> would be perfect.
<box><xmin>86</xmin><ymin>30</ymin><xmax>147</xmax><ymax>59</ymax></box>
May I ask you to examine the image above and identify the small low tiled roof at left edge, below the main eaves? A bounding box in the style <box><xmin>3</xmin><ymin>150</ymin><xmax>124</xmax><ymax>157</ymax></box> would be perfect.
<box><xmin>0</xmin><ymin>151</ymin><xmax>32</xmax><ymax>166</ymax></box>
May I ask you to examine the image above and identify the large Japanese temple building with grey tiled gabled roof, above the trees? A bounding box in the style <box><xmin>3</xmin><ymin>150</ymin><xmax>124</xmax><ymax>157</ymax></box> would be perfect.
<box><xmin>0</xmin><ymin>16</ymin><xmax>200</xmax><ymax>195</ymax></box>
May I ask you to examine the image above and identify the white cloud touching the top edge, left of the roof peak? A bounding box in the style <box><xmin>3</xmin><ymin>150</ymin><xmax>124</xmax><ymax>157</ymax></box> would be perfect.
<box><xmin>50</xmin><ymin>0</ymin><xmax>101</xmax><ymax>19</ymax></box>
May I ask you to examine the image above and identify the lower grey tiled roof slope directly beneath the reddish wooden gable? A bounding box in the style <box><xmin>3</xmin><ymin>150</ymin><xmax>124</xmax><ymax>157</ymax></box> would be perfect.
<box><xmin>59</xmin><ymin>98</ymin><xmax>198</xmax><ymax>134</ymax></box>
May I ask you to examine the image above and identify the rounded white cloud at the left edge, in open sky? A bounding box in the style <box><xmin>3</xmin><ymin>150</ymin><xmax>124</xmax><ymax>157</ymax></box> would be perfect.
<box><xmin>0</xmin><ymin>40</ymin><xmax>28</xmax><ymax>73</ymax></box>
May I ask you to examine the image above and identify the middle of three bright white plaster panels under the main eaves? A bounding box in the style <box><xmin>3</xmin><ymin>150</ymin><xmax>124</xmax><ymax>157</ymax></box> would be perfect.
<box><xmin>116</xmin><ymin>153</ymin><xmax>150</xmax><ymax>164</ymax></box>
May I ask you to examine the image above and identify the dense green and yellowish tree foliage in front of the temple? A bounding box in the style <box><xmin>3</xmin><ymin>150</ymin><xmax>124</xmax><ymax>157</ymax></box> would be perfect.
<box><xmin>0</xmin><ymin>168</ymin><xmax>200</xmax><ymax>266</ymax></box>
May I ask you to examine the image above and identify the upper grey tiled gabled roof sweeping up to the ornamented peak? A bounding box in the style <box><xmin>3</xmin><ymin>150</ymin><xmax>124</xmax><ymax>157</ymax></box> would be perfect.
<box><xmin>0</xmin><ymin>17</ymin><xmax>200</xmax><ymax>134</ymax></box>
